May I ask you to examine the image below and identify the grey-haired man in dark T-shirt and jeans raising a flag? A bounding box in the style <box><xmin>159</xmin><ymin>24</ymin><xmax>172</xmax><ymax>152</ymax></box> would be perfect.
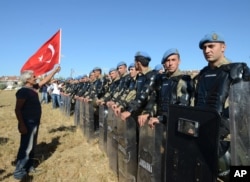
<box><xmin>14</xmin><ymin>66</ymin><xmax>61</xmax><ymax>179</ymax></box>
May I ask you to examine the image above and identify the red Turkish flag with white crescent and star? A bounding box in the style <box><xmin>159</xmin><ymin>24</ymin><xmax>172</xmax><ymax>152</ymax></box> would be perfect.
<box><xmin>21</xmin><ymin>30</ymin><xmax>61</xmax><ymax>76</ymax></box>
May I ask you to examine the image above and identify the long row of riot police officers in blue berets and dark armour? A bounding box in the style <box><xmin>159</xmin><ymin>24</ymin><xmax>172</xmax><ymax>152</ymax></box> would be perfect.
<box><xmin>62</xmin><ymin>32</ymin><xmax>250</xmax><ymax>181</ymax></box>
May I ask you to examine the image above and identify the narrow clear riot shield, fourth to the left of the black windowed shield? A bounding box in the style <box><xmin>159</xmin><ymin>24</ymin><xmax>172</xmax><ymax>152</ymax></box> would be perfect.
<box><xmin>99</xmin><ymin>105</ymin><xmax>108</xmax><ymax>153</ymax></box>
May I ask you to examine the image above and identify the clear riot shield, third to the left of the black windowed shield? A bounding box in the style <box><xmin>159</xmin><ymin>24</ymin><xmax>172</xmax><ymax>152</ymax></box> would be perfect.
<box><xmin>107</xmin><ymin>108</ymin><xmax>118</xmax><ymax>175</ymax></box>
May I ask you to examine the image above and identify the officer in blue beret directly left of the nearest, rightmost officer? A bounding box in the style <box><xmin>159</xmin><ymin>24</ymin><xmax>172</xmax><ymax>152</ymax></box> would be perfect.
<box><xmin>142</xmin><ymin>48</ymin><xmax>193</xmax><ymax>128</ymax></box>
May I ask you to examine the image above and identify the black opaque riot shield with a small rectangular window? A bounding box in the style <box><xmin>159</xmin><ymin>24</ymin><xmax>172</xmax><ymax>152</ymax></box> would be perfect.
<box><xmin>166</xmin><ymin>105</ymin><xmax>221</xmax><ymax>182</ymax></box>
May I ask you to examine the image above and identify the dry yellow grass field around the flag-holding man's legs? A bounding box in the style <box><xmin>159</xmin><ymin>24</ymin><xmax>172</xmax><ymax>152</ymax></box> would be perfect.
<box><xmin>0</xmin><ymin>91</ymin><xmax>118</xmax><ymax>182</ymax></box>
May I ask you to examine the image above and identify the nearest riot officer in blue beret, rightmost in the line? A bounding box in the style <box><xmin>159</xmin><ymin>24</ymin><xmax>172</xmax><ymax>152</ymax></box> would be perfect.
<box><xmin>194</xmin><ymin>32</ymin><xmax>249</xmax><ymax>181</ymax></box>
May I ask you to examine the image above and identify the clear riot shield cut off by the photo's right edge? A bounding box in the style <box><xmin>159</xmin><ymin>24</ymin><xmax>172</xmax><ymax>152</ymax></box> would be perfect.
<box><xmin>229</xmin><ymin>81</ymin><xmax>250</xmax><ymax>166</ymax></box>
